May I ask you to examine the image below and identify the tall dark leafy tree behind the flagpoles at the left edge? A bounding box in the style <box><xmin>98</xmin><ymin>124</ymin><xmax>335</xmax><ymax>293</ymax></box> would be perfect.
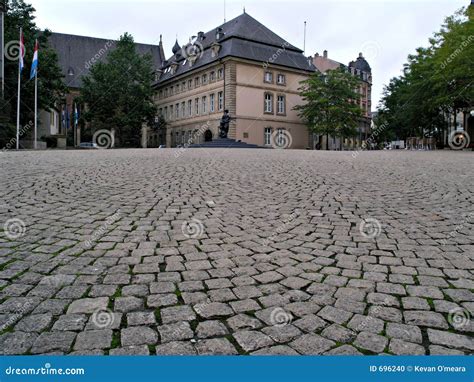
<box><xmin>0</xmin><ymin>0</ymin><xmax>66</xmax><ymax>144</ymax></box>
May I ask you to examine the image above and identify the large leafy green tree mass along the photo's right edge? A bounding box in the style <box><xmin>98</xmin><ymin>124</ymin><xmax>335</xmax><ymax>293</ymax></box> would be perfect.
<box><xmin>379</xmin><ymin>6</ymin><xmax>474</xmax><ymax>146</ymax></box>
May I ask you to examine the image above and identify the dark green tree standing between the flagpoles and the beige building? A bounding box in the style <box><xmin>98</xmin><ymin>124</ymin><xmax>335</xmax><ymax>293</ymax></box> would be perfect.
<box><xmin>81</xmin><ymin>33</ymin><xmax>156</xmax><ymax>147</ymax></box>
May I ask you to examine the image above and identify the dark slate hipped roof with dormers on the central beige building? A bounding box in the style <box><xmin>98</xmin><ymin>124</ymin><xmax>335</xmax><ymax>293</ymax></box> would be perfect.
<box><xmin>157</xmin><ymin>13</ymin><xmax>316</xmax><ymax>85</ymax></box>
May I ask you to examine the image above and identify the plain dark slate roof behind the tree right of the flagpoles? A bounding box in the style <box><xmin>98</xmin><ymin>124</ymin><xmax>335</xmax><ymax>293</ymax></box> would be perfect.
<box><xmin>48</xmin><ymin>33</ymin><xmax>163</xmax><ymax>88</ymax></box>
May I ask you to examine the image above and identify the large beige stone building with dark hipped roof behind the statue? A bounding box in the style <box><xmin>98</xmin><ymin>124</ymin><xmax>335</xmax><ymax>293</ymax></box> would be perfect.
<box><xmin>151</xmin><ymin>12</ymin><xmax>315</xmax><ymax>149</ymax></box>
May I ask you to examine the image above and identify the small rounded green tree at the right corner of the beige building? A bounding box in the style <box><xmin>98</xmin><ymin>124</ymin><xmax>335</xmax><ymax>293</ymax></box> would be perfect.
<box><xmin>294</xmin><ymin>68</ymin><xmax>362</xmax><ymax>149</ymax></box>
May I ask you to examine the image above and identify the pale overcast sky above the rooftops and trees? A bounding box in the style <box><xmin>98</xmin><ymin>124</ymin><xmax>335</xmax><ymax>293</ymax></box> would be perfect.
<box><xmin>30</xmin><ymin>0</ymin><xmax>470</xmax><ymax>110</ymax></box>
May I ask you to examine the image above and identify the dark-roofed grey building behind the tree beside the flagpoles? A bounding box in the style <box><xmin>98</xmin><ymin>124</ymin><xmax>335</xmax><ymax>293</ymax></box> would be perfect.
<box><xmin>38</xmin><ymin>33</ymin><xmax>164</xmax><ymax>147</ymax></box>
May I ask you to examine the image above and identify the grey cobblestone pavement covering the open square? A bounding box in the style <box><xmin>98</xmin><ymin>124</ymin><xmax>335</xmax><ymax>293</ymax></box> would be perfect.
<box><xmin>0</xmin><ymin>149</ymin><xmax>474</xmax><ymax>354</ymax></box>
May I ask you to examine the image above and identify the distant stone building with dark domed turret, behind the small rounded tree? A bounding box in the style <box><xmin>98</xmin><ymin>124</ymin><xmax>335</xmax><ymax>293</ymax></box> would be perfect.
<box><xmin>311</xmin><ymin>50</ymin><xmax>372</xmax><ymax>150</ymax></box>
